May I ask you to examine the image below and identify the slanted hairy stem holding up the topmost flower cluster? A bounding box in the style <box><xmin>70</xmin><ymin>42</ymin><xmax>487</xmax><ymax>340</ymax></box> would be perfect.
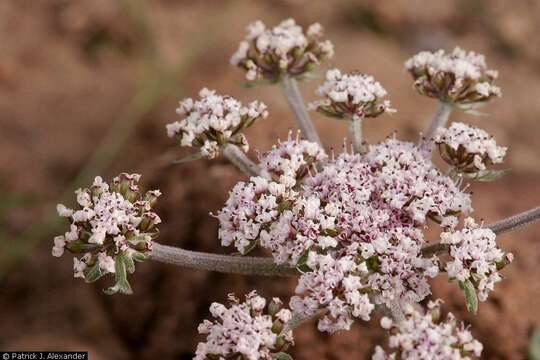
<box><xmin>281</xmin><ymin>76</ymin><xmax>322</xmax><ymax>145</ymax></box>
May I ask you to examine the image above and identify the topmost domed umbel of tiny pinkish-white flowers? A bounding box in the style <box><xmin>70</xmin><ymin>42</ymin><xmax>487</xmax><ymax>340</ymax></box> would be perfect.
<box><xmin>230</xmin><ymin>19</ymin><xmax>334</xmax><ymax>82</ymax></box>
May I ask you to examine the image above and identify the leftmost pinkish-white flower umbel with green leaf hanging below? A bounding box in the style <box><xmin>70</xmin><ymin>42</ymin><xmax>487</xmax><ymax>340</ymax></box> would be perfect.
<box><xmin>52</xmin><ymin>173</ymin><xmax>161</xmax><ymax>294</ymax></box>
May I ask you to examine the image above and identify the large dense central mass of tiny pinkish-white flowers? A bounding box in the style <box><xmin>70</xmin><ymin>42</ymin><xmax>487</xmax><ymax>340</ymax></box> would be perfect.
<box><xmin>218</xmin><ymin>139</ymin><xmax>471</xmax><ymax>331</ymax></box>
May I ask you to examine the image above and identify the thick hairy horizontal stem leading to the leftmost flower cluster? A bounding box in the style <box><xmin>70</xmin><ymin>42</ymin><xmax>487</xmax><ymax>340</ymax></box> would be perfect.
<box><xmin>150</xmin><ymin>242</ymin><xmax>298</xmax><ymax>276</ymax></box>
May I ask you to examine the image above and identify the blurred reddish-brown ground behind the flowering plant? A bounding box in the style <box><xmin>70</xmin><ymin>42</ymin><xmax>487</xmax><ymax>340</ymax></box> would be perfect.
<box><xmin>0</xmin><ymin>0</ymin><xmax>540</xmax><ymax>359</ymax></box>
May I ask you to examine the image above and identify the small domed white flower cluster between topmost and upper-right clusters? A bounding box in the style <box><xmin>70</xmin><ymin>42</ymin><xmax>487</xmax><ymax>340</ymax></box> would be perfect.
<box><xmin>309</xmin><ymin>69</ymin><xmax>396</xmax><ymax>119</ymax></box>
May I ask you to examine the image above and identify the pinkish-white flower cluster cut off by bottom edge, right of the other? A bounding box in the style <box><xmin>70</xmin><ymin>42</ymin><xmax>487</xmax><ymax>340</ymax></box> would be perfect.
<box><xmin>372</xmin><ymin>301</ymin><xmax>483</xmax><ymax>360</ymax></box>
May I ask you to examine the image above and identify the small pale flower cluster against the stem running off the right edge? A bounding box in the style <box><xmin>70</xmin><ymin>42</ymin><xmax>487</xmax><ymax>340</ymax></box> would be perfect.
<box><xmin>441</xmin><ymin>218</ymin><xmax>513</xmax><ymax>301</ymax></box>
